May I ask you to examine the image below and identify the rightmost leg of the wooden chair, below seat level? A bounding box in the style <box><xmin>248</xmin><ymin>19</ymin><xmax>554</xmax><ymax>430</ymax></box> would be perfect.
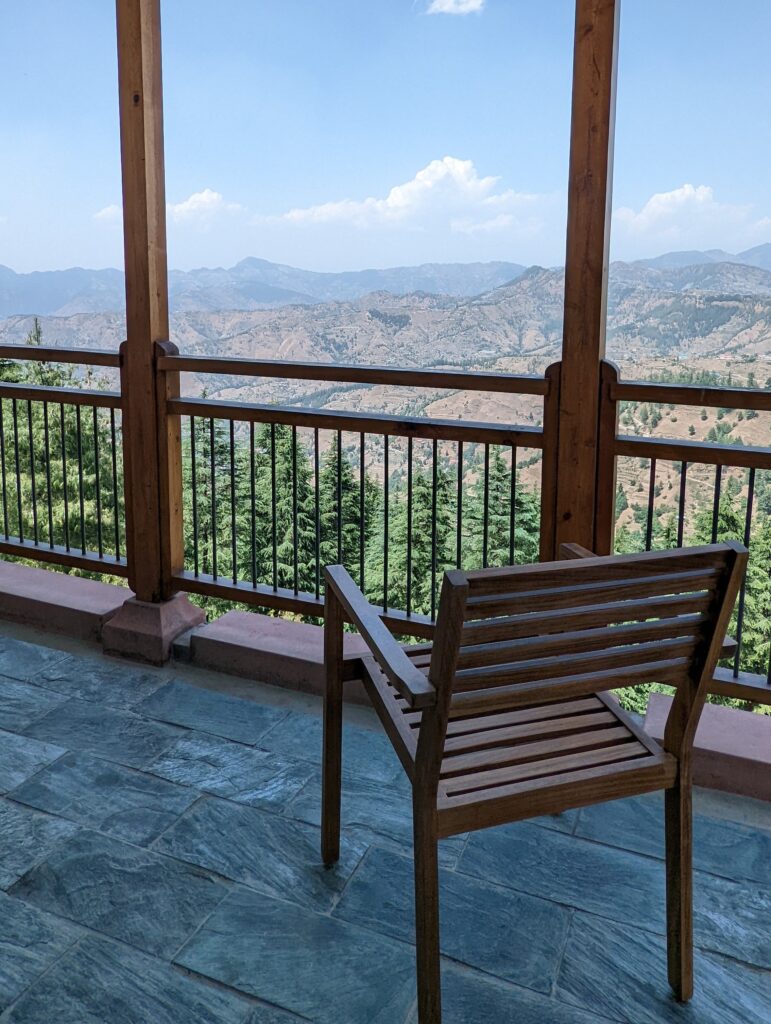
<box><xmin>665</xmin><ymin>770</ymin><xmax>693</xmax><ymax>1002</ymax></box>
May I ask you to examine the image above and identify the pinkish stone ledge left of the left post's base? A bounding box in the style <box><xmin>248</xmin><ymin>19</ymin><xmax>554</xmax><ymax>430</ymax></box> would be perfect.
<box><xmin>0</xmin><ymin>561</ymin><xmax>133</xmax><ymax>640</ymax></box>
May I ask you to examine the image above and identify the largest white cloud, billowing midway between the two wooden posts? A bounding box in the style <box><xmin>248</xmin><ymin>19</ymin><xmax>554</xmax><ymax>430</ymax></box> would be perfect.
<box><xmin>267</xmin><ymin>157</ymin><xmax>544</xmax><ymax>233</ymax></box>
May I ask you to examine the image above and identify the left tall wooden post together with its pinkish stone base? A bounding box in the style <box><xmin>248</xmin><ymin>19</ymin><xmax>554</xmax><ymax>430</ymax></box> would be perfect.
<box><xmin>103</xmin><ymin>0</ymin><xmax>203</xmax><ymax>662</ymax></box>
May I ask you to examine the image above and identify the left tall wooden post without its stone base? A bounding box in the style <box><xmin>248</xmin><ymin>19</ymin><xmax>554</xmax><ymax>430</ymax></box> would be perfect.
<box><xmin>117</xmin><ymin>0</ymin><xmax>181</xmax><ymax>601</ymax></box>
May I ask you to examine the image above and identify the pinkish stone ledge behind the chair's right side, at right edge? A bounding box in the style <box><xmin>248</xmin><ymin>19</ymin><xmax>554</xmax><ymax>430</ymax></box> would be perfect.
<box><xmin>645</xmin><ymin>693</ymin><xmax>771</xmax><ymax>801</ymax></box>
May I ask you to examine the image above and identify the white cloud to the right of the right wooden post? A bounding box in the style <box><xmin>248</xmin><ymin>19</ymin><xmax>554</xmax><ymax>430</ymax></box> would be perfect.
<box><xmin>613</xmin><ymin>183</ymin><xmax>771</xmax><ymax>257</ymax></box>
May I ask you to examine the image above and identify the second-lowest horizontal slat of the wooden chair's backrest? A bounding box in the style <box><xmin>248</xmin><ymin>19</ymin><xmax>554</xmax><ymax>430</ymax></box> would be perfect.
<box><xmin>458</xmin><ymin>614</ymin><xmax>709</xmax><ymax>670</ymax></box>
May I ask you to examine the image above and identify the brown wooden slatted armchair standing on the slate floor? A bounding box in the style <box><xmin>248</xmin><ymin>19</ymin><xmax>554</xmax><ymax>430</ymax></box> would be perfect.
<box><xmin>322</xmin><ymin>543</ymin><xmax>746</xmax><ymax>1024</ymax></box>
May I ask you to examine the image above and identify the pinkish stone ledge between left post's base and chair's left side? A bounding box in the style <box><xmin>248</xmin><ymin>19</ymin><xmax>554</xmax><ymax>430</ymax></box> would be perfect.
<box><xmin>189</xmin><ymin>611</ymin><xmax>369</xmax><ymax>703</ymax></box>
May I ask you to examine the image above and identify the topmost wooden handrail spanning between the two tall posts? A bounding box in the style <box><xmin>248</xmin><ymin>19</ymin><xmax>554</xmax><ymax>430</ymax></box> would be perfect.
<box><xmin>157</xmin><ymin>355</ymin><xmax>550</xmax><ymax>396</ymax></box>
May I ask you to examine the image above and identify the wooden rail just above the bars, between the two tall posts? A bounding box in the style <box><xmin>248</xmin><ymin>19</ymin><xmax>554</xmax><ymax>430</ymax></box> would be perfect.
<box><xmin>167</xmin><ymin>398</ymin><xmax>544</xmax><ymax>449</ymax></box>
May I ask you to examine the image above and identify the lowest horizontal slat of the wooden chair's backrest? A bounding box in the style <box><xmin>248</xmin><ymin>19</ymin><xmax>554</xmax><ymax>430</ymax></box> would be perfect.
<box><xmin>454</xmin><ymin>657</ymin><xmax>691</xmax><ymax>713</ymax></box>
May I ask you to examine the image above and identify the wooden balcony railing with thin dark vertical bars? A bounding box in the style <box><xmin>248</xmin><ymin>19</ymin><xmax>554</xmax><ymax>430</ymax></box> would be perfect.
<box><xmin>0</xmin><ymin>345</ymin><xmax>771</xmax><ymax>702</ymax></box>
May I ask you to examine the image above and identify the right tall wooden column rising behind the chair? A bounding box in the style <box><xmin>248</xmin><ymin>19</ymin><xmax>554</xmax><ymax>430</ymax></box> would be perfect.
<box><xmin>555</xmin><ymin>0</ymin><xmax>620</xmax><ymax>550</ymax></box>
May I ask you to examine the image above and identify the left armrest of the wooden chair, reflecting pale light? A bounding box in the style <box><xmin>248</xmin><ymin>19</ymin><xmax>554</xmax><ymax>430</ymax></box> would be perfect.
<box><xmin>324</xmin><ymin>565</ymin><xmax>436</xmax><ymax>709</ymax></box>
